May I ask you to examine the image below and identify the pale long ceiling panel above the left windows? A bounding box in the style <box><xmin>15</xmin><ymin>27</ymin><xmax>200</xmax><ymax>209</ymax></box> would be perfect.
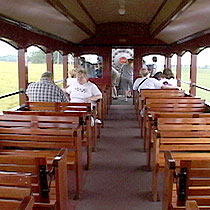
<box><xmin>0</xmin><ymin>0</ymin><xmax>89</xmax><ymax>43</ymax></box>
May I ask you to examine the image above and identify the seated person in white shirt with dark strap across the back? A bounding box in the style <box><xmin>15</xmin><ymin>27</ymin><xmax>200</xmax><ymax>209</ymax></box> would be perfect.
<box><xmin>133</xmin><ymin>68</ymin><xmax>176</xmax><ymax>91</ymax></box>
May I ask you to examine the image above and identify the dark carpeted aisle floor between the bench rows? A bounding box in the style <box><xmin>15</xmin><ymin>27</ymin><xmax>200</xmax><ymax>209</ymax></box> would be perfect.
<box><xmin>76</xmin><ymin>101</ymin><xmax>161</xmax><ymax>210</ymax></box>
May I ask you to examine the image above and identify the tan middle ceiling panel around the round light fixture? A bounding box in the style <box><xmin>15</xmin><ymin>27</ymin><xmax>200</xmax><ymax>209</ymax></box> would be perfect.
<box><xmin>81</xmin><ymin>0</ymin><xmax>164</xmax><ymax>24</ymax></box>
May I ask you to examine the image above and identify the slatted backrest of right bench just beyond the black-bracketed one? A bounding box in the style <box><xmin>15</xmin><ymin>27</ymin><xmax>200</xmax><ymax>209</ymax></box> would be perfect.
<box><xmin>156</xmin><ymin>118</ymin><xmax>210</xmax><ymax>151</ymax></box>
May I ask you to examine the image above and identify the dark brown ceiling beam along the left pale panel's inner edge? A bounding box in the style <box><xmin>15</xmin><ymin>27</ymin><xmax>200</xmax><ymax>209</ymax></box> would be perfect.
<box><xmin>44</xmin><ymin>0</ymin><xmax>94</xmax><ymax>36</ymax></box>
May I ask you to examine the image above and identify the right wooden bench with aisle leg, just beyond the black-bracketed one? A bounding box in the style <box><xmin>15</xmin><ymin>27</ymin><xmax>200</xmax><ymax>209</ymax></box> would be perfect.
<box><xmin>152</xmin><ymin>118</ymin><xmax>210</xmax><ymax>201</ymax></box>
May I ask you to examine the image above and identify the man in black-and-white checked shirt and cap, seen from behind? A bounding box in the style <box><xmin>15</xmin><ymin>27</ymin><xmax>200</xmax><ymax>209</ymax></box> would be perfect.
<box><xmin>26</xmin><ymin>72</ymin><xmax>68</xmax><ymax>102</ymax></box>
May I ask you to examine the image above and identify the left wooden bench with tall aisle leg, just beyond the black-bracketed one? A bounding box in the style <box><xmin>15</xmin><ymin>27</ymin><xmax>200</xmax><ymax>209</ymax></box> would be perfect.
<box><xmin>0</xmin><ymin>114</ymin><xmax>83</xmax><ymax>198</ymax></box>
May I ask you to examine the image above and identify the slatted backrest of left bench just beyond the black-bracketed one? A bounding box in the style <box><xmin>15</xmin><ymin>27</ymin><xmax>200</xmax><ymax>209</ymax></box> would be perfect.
<box><xmin>0</xmin><ymin>114</ymin><xmax>81</xmax><ymax>151</ymax></box>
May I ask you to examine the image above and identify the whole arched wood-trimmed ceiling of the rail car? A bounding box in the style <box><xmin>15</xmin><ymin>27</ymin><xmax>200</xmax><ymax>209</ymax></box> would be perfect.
<box><xmin>0</xmin><ymin>0</ymin><xmax>210</xmax><ymax>46</ymax></box>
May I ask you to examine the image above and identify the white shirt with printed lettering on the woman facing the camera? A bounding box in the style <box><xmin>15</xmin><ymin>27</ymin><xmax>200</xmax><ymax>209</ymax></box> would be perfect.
<box><xmin>66</xmin><ymin>80</ymin><xmax>102</xmax><ymax>103</ymax></box>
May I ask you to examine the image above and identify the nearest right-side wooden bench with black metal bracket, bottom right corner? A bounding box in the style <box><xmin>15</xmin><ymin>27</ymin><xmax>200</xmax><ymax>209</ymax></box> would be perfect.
<box><xmin>162</xmin><ymin>151</ymin><xmax>210</xmax><ymax>210</ymax></box>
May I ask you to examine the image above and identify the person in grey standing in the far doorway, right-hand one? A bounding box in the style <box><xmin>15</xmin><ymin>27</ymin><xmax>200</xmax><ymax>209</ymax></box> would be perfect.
<box><xmin>121</xmin><ymin>58</ymin><xmax>133</xmax><ymax>101</ymax></box>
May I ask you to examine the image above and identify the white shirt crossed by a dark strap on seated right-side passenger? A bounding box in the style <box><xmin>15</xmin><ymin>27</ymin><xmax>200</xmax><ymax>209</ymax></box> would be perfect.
<box><xmin>133</xmin><ymin>77</ymin><xmax>163</xmax><ymax>91</ymax></box>
